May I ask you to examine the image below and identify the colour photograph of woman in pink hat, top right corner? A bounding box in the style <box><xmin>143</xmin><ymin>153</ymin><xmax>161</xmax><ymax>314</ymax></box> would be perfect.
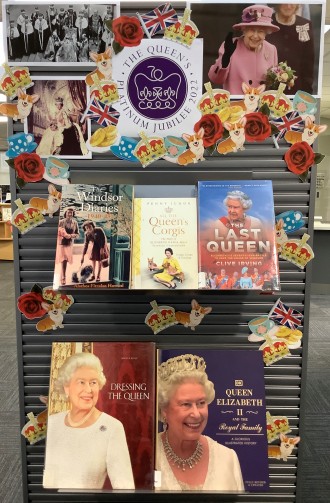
<box><xmin>189</xmin><ymin>0</ymin><xmax>324</xmax><ymax>97</ymax></box>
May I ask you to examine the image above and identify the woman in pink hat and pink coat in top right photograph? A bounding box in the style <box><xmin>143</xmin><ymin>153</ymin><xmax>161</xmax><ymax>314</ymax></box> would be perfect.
<box><xmin>208</xmin><ymin>4</ymin><xmax>279</xmax><ymax>95</ymax></box>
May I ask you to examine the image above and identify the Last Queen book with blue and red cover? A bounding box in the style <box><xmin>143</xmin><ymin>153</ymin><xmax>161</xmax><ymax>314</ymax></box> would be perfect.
<box><xmin>198</xmin><ymin>180</ymin><xmax>280</xmax><ymax>291</ymax></box>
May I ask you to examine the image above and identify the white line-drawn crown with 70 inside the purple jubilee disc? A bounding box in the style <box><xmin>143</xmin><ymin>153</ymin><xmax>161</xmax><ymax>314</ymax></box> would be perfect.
<box><xmin>134</xmin><ymin>67</ymin><xmax>182</xmax><ymax>110</ymax></box>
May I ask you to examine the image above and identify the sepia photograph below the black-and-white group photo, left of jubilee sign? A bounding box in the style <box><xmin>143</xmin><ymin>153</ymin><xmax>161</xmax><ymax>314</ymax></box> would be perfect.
<box><xmin>25</xmin><ymin>77</ymin><xmax>92</xmax><ymax>159</ymax></box>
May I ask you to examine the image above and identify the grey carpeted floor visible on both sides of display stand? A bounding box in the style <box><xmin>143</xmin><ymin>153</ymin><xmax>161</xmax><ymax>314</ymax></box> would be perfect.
<box><xmin>0</xmin><ymin>262</ymin><xmax>330</xmax><ymax>503</ymax></box>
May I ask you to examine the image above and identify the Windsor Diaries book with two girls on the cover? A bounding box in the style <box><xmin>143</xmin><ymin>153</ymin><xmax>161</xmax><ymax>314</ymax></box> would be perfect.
<box><xmin>54</xmin><ymin>184</ymin><xmax>133</xmax><ymax>289</ymax></box>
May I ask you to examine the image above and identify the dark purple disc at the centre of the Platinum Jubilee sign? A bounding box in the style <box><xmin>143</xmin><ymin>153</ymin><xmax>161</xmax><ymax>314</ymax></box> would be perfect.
<box><xmin>127</xmin><ymin>56</ymin><xmax>188</xmax><ymax>120</ymax></box>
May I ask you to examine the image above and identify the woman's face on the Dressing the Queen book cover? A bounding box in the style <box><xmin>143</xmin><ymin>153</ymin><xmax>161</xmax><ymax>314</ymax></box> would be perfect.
<box><xmin>64</xmin><ymin>367</ymin><xmax>100</xmax><ymax>411</ymax></box>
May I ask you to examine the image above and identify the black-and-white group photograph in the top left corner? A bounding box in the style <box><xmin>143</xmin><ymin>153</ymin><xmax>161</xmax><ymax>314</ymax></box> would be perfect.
<box><xmin>3</xmin><ymin>1</ymin><xmax>119</xmax><ymax>66</ymax></box>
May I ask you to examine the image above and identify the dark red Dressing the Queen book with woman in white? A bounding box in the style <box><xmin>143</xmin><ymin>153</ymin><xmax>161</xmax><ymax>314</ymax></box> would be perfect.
<box><xmin>43</xmin><ymin>342</ymin><xmax>155</xmax><ymax>491</ymax></box>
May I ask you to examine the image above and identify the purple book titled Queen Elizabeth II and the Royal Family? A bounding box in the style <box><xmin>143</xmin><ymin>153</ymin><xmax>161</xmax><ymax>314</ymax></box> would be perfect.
<box><xmin>156</xmin><ymin>347</ymin><xmax>269</xmax><ymax>492</ymax></box>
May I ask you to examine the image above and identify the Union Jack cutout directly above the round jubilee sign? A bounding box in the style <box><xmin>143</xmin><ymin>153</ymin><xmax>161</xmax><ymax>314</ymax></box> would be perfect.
<box><xmin>136</xmin><ymin>3</ymin><xmax>178</xmax><ymax>38</ymax></box>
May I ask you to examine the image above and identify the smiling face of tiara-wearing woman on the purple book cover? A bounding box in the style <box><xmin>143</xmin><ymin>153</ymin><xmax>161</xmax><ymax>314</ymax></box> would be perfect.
<box><xmin>164</xmin><ymin>381</ymin><xmax>208</xmax><ymax>442</ymax></box>
